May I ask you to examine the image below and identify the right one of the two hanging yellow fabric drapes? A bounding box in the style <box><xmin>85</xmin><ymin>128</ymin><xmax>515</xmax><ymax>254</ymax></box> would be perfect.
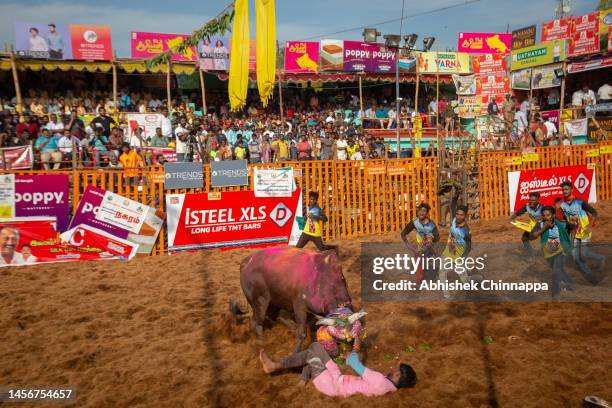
<box><xmin>255</xmin><ymin>0</ymin><xmax>276</xmax><ymax>107</ymax></box>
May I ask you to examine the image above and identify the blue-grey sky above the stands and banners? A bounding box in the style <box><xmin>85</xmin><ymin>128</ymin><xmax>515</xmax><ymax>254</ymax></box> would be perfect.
<box><xmin>0</xmin><ymin>0</ymin><xmax>598</xmax><ymax>57</ymax></box>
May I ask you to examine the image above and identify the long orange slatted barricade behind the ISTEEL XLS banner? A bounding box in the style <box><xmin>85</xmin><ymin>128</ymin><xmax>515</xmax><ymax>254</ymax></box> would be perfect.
<box><xmin>1</xmin><ymin>157</ymin><xmax>438</xmax><ymax>255</ymax></box>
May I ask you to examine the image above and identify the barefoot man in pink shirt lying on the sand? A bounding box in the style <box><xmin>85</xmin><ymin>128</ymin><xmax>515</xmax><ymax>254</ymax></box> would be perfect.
<box><xmin>259</xmin><ymin>342</ymin><xmax>416</xmax><ymax>397</ymax></box>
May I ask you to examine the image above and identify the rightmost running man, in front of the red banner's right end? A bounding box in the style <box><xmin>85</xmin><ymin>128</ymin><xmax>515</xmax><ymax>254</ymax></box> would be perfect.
<box><xmin>560</xmin><ymin>181</ymin><xmax>606</xmax><ymax>284</ymax></box>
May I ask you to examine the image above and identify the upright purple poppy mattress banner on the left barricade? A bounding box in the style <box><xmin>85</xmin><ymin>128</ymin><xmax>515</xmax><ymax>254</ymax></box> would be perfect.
<box><xmin>15</xmin><ymin>174</ymin><xmax>70</xmax><ymax>231</ymax></box>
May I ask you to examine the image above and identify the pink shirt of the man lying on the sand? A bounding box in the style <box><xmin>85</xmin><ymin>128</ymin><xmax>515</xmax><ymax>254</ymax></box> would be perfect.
<box><xmin>312</xmin><ymin>360</ymin><xmax>397</xmax><ymax>397</ymax></box>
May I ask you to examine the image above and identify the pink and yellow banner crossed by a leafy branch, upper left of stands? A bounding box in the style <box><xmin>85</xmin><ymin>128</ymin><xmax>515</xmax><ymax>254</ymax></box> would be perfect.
<box><xmin>130</xmin><ymin>31</ymin><xmax>197</xmax><ymax>61</ymax></box>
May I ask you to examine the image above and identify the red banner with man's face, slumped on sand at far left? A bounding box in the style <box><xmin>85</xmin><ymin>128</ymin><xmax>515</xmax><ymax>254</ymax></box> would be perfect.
<box><xmin>0</xmin><ymin>217</ymin><xmax>136</xmax><ymax>267</ymax></box>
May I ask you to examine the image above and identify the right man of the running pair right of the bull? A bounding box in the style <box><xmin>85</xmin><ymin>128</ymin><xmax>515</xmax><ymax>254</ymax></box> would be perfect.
<box><xmin>438</xmin><ymin>205</ymin><xmax>472</xmax><ymax>299</ymax></box>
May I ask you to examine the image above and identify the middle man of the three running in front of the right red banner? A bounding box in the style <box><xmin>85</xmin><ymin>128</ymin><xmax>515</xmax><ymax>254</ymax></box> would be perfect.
<box><xmin>530</xmin><ymin>206</ymin><xmax>575</xmax><ymax>300</ymax></box>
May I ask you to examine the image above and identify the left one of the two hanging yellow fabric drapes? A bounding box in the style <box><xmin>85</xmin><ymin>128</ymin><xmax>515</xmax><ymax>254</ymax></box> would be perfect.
<box><xmin>228</xmin><ymin>0</ymin><xmax>250</xmax><ymax>112</ymax></box>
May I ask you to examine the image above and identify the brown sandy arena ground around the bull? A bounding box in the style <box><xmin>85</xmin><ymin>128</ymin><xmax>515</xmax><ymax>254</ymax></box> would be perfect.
<box><xmin>0</xmin><ymin>202</ymin><xmax>612</xmax><ymax>407</ymax></box>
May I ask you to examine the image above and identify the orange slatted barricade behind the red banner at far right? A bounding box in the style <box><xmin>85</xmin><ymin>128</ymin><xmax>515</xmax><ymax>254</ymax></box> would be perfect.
<box><xmin>478</xmin><ymin>141</ymin><xmax>612</xmax><ymax>220</ymax></box>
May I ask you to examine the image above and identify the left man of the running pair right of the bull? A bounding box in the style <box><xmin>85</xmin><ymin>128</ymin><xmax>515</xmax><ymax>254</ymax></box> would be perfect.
<box><xmin>402</xmin><ymin>203</ymin><xmax>440</xmax><ymax>282</ymax></box>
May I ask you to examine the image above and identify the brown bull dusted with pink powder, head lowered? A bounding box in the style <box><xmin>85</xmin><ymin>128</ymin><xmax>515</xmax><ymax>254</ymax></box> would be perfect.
<box><xmin>240</xmin><ymin>247</ymin><xmax>352</xmax><ymax>351</ymax></box>
